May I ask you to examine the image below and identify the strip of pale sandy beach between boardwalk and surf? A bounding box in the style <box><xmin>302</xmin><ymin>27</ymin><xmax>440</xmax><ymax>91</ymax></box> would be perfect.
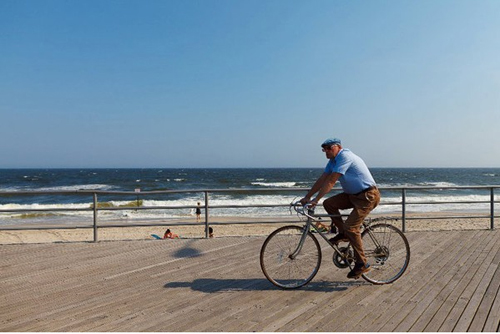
<box><xmin>0</xmin><ymin>213</ymin><xmax>499</xmax><ymax>244</ymax></box>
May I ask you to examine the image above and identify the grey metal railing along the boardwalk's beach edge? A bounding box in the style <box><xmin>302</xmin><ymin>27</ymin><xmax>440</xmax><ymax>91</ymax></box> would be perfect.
<box><xmin>0</xmin><ymin>185</ymin><xmax>500</xmax><ymax>242</ymax></box>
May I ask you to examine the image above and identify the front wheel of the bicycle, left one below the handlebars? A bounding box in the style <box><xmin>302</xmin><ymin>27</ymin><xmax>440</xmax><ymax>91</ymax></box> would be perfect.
<box><xmin>260</xmin><ymin>226</ymin><xmax>321</xmax><ymax>289</ymax></box>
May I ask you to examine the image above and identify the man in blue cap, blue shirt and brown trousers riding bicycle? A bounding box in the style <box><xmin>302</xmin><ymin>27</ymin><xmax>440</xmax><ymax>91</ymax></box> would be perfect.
<box><xmin>300</xmin><ymin>138</ymin><xmax>380</xmax><ymax>279</ymax></box>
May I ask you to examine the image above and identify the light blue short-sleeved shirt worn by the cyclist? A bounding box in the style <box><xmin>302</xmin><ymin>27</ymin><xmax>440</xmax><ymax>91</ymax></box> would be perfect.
<box><xmin>325</xmin><ymin>148</ymin><xmax>376</xmax><ymax>195</ymax></box>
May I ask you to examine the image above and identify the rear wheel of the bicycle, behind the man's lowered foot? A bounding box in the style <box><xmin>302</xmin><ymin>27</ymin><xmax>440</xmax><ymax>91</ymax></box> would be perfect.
<box><xmin>361</xmin><ymin>224</ymin><xmax>410</xmax><ymax>284</ymax></box>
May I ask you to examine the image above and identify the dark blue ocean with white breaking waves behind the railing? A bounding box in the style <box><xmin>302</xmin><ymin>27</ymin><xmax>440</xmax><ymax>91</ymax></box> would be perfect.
<box><xmin>0</xmin><ymin>168</ymin><xmax>500</xmax><ymax>224</ymax></box>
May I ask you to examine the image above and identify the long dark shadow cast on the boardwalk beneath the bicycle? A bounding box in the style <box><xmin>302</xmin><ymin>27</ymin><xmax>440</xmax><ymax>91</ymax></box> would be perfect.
<box><xmin>163</xmin><ymin>278</ymin><xmax>368</xmax><ymax>293</ymax></box>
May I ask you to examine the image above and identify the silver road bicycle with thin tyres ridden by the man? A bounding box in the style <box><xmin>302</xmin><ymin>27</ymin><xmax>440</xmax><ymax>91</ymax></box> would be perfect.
<box><xmin>260</xmin><ymin>202</ymin><xmax>410</xmax><ymax>289</ymax></box>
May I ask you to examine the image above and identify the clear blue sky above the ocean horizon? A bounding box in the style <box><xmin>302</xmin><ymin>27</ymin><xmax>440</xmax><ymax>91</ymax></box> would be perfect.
<box><xmin>0</xmin><ymin>0</ymin><xmax>500</xmax><ymax>168</ymax></box>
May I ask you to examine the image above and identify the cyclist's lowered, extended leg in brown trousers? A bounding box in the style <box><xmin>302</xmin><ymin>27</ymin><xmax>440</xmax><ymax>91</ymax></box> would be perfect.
<box><xmin>344</xmin><ymin>189</ymin><xmax>380</xmax><ymax>264</ymax></box>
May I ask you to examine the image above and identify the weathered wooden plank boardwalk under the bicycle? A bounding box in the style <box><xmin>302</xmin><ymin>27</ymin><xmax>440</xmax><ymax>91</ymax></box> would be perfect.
<box><xmin>0</xmin><ymin>230</ymin><xmax>500</xmax><ymax>332</ymax></box>
